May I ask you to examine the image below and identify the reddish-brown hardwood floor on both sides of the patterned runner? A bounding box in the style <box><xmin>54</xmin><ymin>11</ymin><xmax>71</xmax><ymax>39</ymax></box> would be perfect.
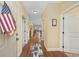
<box><xmin>20</xmin><ymin>32</ymin><xmax>67</xmax><ymax>57</ymax></box>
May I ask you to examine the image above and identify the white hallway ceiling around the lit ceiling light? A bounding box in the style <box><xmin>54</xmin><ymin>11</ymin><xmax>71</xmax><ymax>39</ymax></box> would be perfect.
<box><xmin>22</xmin><ymin>1</ymin><xmax>60</xmax><ymax>25</ymax></box>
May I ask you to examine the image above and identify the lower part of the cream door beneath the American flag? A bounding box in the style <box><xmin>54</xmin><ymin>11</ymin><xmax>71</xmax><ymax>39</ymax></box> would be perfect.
<box><xmin>0</xmin><ymin>33</ymin><xmax>17</xmax><ymax>57</ymax></box>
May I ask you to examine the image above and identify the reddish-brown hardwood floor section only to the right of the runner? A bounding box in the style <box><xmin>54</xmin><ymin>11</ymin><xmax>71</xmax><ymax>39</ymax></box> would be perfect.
<box><xmin>41</xmin><ymin>41</ymin><xmax>67</xmax><ymax>57</ymax></box>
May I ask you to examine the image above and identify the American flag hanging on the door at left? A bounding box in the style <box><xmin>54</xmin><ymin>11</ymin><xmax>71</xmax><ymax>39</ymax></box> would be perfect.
<box><xmin>0</xmin><ymin>2</ymin><xmax>16</xmax><ymax>34</ymax></box>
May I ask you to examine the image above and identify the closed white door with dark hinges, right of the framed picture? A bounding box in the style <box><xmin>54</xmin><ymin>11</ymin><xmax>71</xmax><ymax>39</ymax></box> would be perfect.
<box><xmin>64</xmin><ymin>15</ymin><xmax>79</xmax><ymax>51</ymax></box>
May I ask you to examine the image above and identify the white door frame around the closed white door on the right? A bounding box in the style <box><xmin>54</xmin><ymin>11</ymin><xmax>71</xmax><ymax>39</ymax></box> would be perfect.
<box><xmin>60</xmin><ymin>2</ymin><xmax>79</xmax><ymax>52</ymax></box>
